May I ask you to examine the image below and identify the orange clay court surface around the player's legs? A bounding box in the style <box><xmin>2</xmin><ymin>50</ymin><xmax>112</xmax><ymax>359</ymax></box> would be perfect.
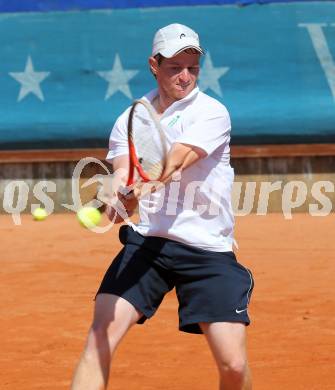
<box><xmin>0</xmin><ymin>214</ymin><xmax>335</xmax><ymax>390</ymax></box>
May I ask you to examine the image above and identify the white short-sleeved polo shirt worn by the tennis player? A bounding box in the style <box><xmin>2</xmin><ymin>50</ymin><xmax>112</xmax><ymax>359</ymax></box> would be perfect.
<box><xmin>107</xmin><ymin>88</ymin><xmax>234</xmax><ymax>252</ymax></box>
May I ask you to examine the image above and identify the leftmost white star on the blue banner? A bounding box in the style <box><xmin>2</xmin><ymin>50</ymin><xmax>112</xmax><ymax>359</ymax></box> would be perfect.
<box><xmin>9</xmin><ymin>56</ymin><xmax>50</xmax><ymax>102</ymax></box>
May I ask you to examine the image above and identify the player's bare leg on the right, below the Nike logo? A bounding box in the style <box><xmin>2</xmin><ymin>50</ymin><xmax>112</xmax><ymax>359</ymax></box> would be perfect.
<box><xmin>199</xmin><ymin>322</ymin><xmax>251</xmax><ymax>390</ymax></box>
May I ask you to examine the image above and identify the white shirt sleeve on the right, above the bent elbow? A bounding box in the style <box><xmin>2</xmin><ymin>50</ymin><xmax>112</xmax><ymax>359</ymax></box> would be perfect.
<box><xmin>175</xmin><ymin>110</ymin><xmax>231</xmax><ymax>155</ymax></box>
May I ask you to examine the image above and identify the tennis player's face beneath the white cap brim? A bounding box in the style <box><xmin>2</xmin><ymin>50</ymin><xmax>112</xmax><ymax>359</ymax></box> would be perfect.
<box><xmin>150</xmin><ymin>50</ymin><xmax>200</xmax><ymax>101</ymax></box>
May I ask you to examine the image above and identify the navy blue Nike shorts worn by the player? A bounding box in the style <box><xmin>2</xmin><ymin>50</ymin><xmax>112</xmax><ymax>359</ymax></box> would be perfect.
<box><xmin>97</xmin><ymin>225</ymin><xmax>254</xmax><ymax>333</ymax></box>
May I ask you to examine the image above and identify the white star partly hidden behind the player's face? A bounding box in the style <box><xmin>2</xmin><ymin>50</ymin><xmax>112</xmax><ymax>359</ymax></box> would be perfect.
<box><xmin>199</xmin><ymin>52</ymin><xmax>229</xmax><ymax>97</ymax></box>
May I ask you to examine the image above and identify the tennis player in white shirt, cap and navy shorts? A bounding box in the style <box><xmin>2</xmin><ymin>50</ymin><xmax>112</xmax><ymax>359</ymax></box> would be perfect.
<box><xmin>72</xmin><ymin>24</ymin><xmax>253</xmax><ymax>390</ymax></box>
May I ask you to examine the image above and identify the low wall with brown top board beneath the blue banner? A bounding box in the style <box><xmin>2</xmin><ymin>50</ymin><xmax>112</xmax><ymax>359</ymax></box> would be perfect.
<box><xmin>0</xmin><ymin>144</ymin><xmax>335</xmax><ymax>215</ymax></box>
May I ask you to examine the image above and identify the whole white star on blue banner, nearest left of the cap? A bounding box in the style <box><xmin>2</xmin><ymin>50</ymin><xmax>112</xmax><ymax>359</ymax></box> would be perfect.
<box><xmin>97</xmin><ymin>54</ymin><xmax>138</xmax><ymax>100</ymax></box>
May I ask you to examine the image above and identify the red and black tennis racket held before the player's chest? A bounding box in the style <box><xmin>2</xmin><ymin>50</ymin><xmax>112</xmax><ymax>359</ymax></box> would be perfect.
<box><xmin>99</xmin><ymin>99</ymin><xmax>167</xmax><ymax>204</ymax></box>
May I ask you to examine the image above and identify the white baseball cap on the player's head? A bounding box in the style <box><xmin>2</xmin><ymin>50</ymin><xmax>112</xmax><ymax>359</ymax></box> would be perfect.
<box><xmin>152</xmin><ymin>23</ymin><xmax>204</xmax><ymax>58</ymax></box>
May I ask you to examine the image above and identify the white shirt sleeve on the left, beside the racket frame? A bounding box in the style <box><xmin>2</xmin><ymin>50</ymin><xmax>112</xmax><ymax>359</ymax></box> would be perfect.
<box><xmin>106</xmin><ymin>110</ymin><xmax>129</xmax><ymax>162</ymax></box>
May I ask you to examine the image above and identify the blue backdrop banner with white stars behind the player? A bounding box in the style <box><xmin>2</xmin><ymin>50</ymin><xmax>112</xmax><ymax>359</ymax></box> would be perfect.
<box><xmin>0</xmin><ymin>2</ymin><xmax>335</xmax><ymax>149</ymax></box>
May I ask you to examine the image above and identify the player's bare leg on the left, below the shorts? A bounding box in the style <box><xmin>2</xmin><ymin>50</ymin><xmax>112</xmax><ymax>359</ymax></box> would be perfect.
<box><xmin>71</xmin><ymin>294</ymin><xmax>142</xmax><ymax>390</ymax></box>
